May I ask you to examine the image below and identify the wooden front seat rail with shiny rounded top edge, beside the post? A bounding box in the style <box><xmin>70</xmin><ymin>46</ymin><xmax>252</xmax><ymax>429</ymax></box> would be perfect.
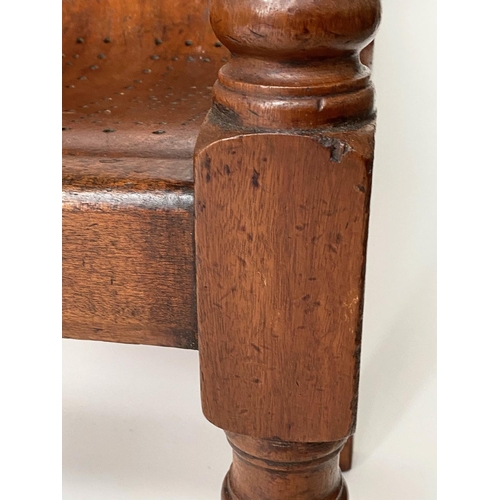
<box><xmin>63</xmin><ymin>157</ymin><xmax>197</xmax><ymax>349</ymax></box>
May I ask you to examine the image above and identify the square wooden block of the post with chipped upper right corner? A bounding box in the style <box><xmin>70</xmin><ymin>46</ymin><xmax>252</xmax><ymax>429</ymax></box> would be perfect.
<box><xmin>195</xmin><ymin>128</ymin><xmax>374</xmax><ymax>442</ymax></box>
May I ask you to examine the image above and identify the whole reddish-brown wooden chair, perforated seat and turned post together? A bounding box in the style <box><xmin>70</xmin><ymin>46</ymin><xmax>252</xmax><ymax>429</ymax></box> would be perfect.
<box><xmin>62</xmin><ymin>0</ymin><xmax>380</xmax><ymax>500</ymax></box>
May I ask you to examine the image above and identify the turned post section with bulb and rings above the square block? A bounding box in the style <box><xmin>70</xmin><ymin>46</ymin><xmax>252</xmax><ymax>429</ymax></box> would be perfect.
<box><xmin>210</xmin><ymin>0</ymin><xmax>381</xmax><ymax>129</ymax></box>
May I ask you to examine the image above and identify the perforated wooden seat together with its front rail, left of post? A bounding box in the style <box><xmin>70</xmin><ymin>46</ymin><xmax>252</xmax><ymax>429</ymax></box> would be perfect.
<box><xmin>63</xmin><ymin>0</ymin><xmax>228</xmax><ymax>348</ymax></box>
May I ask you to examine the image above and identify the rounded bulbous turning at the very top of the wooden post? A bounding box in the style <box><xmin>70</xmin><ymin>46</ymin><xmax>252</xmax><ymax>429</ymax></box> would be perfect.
<box><xmin>210</xmin><ymin>0</ymin><xmax>381</xmax><ymax>60</ymax></box>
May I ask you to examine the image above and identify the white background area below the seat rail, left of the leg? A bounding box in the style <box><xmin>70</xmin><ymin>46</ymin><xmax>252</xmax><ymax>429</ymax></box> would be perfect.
<box><xmin>62</xmin><ymin>341</ymin><xmax>231</xmax><ymax>500</ymax></box>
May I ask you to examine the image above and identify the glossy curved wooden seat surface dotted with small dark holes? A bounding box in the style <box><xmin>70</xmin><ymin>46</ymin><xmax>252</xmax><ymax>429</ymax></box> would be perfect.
<box><xmin>63</xmin><ymin>0</ymin><xmax>228</xmax><ymax>158</ymax></box>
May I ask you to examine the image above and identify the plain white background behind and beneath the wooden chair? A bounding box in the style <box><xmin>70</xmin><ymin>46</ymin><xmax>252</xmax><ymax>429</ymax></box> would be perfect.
<box><xmin>63</xmin><ymin>0</ymin><xmax>436</xmax><ymax>500</ymax></box>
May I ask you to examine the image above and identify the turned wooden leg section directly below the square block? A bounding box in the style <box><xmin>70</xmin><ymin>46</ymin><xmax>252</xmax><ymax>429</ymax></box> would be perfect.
<box><xmin>222</xmin><ymin>433</ymin><xmax>348</xmax><ymax>500</ymax></box>
